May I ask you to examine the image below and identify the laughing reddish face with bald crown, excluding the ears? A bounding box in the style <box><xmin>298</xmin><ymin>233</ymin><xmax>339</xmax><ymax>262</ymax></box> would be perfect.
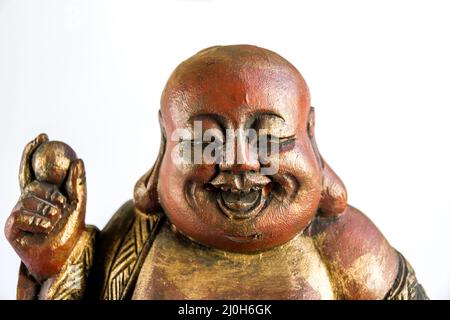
<box><xmin>158</xmin><ymin>46</ymin><xmax>321</xmax><ymax>252</ymax></box>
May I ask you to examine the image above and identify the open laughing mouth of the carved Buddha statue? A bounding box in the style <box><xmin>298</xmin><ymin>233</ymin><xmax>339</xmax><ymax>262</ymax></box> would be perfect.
<box><xmin>214</xmin><ymin>185</ymin><xmax>270</xmax><ymax>219</ymax></box>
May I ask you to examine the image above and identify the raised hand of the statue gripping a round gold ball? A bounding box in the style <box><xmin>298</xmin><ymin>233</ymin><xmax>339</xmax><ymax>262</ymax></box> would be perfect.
<box><xmin>5</xmin><ymin>134</ymin><xmax>86</xmax><ymax>282</ymax></box>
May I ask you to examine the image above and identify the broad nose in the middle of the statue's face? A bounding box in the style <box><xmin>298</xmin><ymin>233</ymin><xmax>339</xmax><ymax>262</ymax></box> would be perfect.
<box><xmin>219</xmin><ymin>133</ymin><xmax>260</xmax><ymax>173</ymax></box>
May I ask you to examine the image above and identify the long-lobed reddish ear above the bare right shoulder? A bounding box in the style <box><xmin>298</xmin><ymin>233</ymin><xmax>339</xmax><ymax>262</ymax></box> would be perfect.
<box><xmin>307</xmin><ymin>107</ymin><xmax>347</xmax><ymax>216</ymax></box>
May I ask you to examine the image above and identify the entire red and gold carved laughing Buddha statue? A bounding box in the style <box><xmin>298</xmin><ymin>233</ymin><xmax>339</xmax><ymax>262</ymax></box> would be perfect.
<box><xmin>5</xmin><ymin>45</ymin><xmax>427</xmax><ymax>299</ymax></box>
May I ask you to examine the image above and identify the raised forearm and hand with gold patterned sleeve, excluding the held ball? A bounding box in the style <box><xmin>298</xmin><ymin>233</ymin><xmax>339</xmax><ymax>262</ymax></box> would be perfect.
<box><xmin>5</xmin><ymin>134</ymin><xmax>97</xmax><ymax>300</ymax></box>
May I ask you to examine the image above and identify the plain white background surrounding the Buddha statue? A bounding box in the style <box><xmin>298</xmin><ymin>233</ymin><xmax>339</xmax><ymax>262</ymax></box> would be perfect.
<box><xmin>0</xmin><ymin>0</ymin><xmax>450</xmax><ymax>299</ymax></box>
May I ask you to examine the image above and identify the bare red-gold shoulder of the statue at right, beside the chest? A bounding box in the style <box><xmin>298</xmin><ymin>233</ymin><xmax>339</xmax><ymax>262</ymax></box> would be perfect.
<box><xmin>309</xmin><ymin>206</ymin><xmax>399</xmax><ymax>299</ymax></box>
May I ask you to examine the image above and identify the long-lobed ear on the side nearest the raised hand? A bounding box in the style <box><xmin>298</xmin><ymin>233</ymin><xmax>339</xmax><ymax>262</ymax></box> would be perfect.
<box><xmin>133</xmin><ymin>111</ymin><xmax>166</xmax><ymax>214</ymax></box>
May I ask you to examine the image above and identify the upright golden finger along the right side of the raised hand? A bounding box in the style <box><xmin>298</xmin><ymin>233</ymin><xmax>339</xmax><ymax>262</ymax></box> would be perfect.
<box><xmin>66</xmin><ymin>159</ymin><xmax>87</xmax><ymax>220</ymax></box>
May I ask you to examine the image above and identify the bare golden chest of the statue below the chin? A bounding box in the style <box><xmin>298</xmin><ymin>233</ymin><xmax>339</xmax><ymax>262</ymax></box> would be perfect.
<box><xmin>133</xmin><ymin>222</ymin><xmax>334</xmax><ymax>299</ymax></box>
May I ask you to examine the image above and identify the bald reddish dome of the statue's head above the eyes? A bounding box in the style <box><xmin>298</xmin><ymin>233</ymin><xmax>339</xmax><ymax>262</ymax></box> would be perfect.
<box><xmin>161</xmin><ymin>45</ymin><xmax>309</xmax><ymax>131</ymax></box>
